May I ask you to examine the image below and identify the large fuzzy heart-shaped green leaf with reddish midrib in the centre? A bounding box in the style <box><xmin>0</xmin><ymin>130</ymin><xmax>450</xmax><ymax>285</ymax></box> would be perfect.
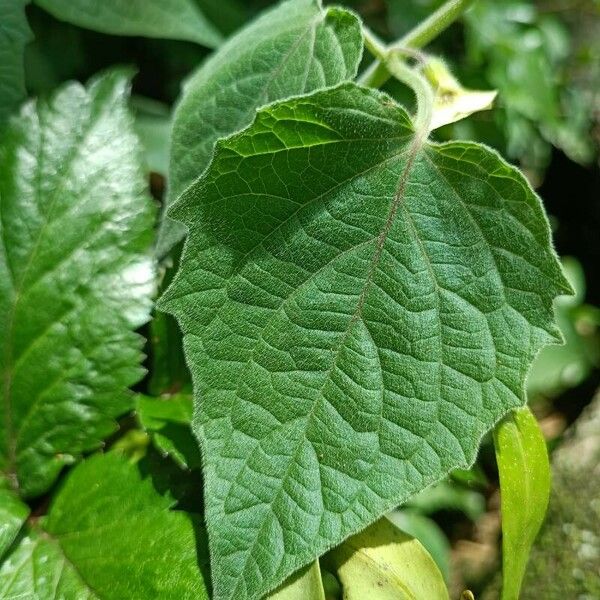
<box><xmin>162</xmin><ymin>83</ymin><xmax>569</xmax><ymax>600</ymax></box>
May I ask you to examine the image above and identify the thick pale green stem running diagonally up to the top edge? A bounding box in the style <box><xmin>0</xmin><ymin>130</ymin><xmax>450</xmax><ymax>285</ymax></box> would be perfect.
<box><xmin>358</xmin><ymin>0</ymin><xmax>475</xmax><ymax>87</ymax></box>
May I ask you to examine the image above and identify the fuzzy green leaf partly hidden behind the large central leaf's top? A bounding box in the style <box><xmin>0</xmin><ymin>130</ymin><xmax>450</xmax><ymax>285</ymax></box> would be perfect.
<box><xmin>157</xmin><ymin>0</ymin><xmax>363</xmax><ymax>256</ymax></box>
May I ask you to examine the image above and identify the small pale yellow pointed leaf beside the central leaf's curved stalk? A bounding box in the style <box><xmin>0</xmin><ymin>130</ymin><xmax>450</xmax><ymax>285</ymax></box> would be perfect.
<box><xmin>423</xmin><ymin>58</ymin><xmax>497</xmax><ymax>129</ymax></box>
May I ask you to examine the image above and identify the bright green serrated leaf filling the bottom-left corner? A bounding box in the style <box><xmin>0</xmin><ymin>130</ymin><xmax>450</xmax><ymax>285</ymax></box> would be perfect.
<box><xmin>0</xmin><ymin>453</ymin><xmax>208</xmax><ymax>600</ymax></box>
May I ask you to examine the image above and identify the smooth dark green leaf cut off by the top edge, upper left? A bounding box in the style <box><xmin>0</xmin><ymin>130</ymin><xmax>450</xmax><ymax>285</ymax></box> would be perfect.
<box><xmin>35</xmin><ymin>0</ymin><xmax>222</xmax><ymax>48</ymax></box>
